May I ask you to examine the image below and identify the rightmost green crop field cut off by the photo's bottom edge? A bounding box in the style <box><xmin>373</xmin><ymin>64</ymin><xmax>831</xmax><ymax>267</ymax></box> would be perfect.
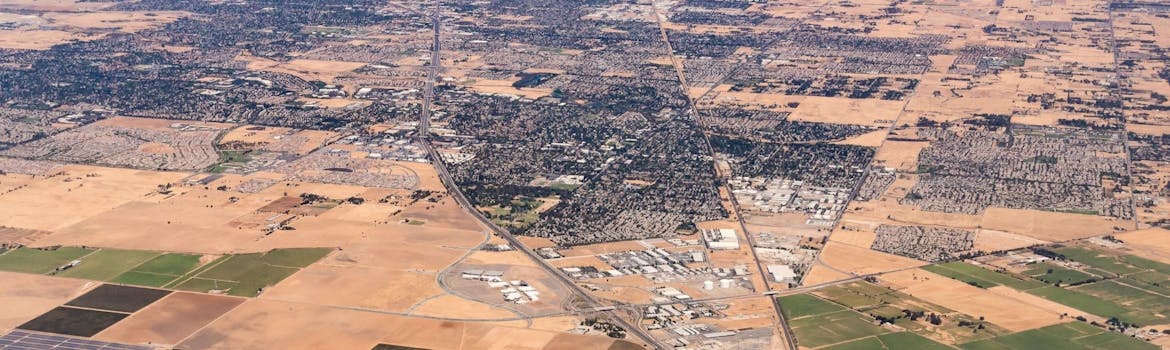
<box><xmin>961</xmin><ymin>322</ymin><xmax>1157</xmax><ymax>350</ymax></box>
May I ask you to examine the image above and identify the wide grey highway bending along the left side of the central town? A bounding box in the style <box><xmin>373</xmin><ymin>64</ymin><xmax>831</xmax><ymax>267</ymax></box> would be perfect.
<box><xmin>415</xmin><ymin>2</ymin><xmax>668</xmax><ymax>350</ymax></box>
